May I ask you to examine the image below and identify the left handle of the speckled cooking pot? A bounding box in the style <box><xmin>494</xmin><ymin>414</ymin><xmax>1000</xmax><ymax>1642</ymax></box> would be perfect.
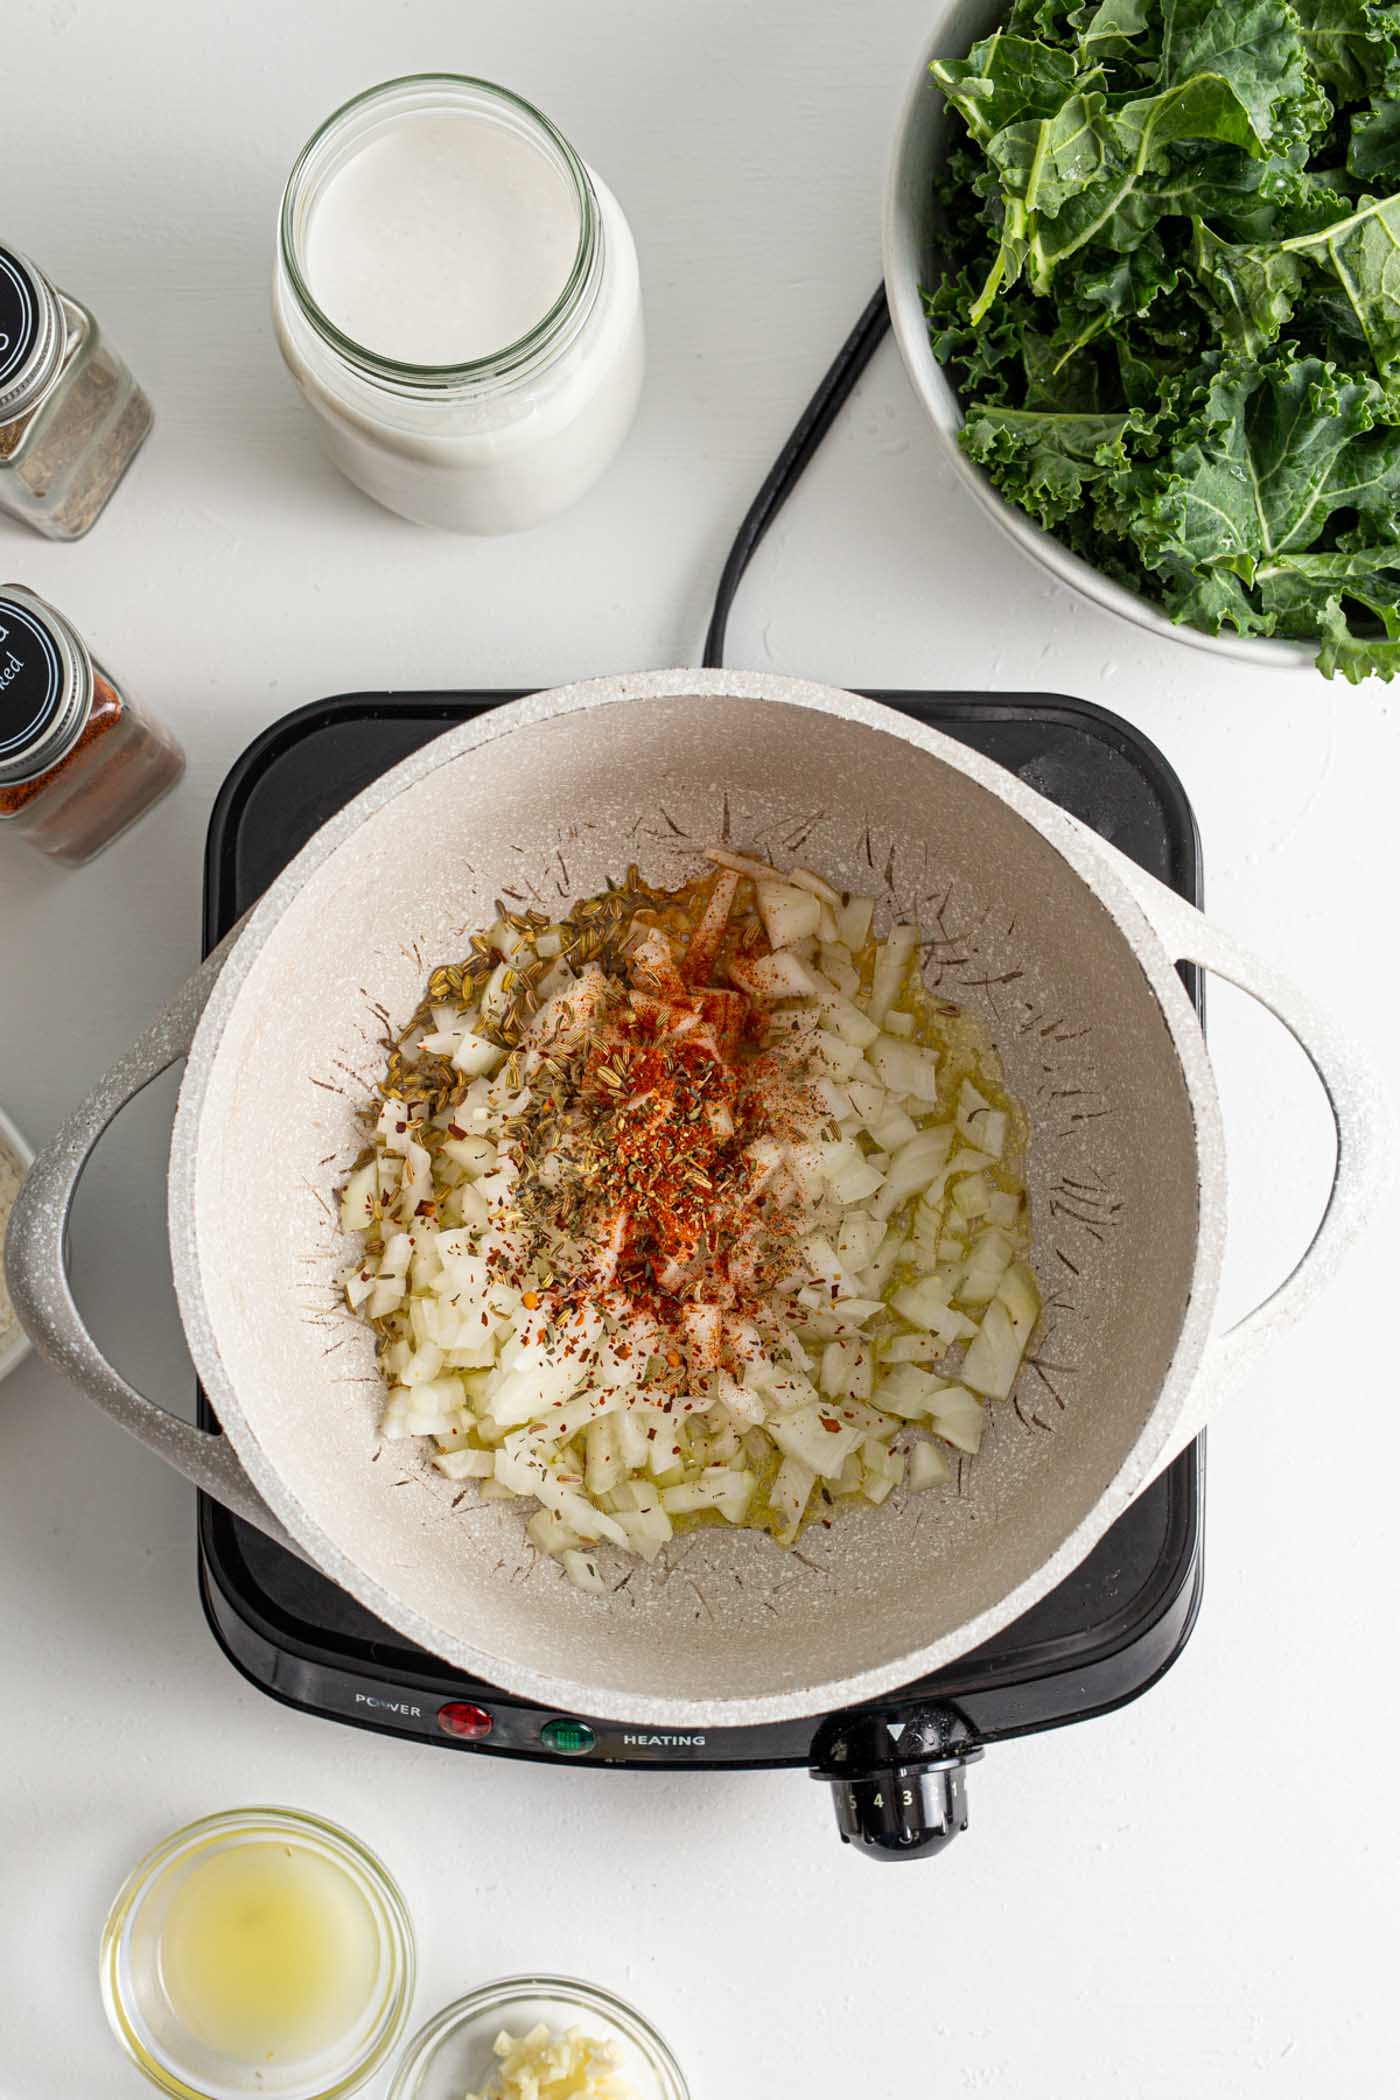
<box><xmin>4</xmin><ymin>926</ymin><xmax>304</xmax><ymax>1558</ymax></box>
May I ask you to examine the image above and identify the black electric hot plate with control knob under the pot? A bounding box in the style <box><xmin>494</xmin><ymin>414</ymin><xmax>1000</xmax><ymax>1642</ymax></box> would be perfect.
<box><xmin>199</xmin><ymin>693</ymin><xmax>1205</xmax><ymax>1859</ymax></box>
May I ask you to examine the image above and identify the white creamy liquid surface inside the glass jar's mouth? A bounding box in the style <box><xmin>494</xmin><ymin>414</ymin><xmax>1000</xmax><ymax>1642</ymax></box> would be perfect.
<box><xmin>304</xmin><ymin>111</ymin><xmax>579</xmax><ymax>365</ymax></box>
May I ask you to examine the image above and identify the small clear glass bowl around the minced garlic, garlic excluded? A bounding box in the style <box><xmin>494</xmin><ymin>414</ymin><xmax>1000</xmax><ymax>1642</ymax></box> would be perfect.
<box><xmin>388</xmin><ymin>1976</ymin><xmax>691</xmax><ymax>2100</ymax></box>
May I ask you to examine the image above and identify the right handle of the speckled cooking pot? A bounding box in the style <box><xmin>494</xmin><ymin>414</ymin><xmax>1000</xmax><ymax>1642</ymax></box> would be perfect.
<box><xmin>1094</xmin><ymin>840</ymin><xmax>1392</xmax><ymax>1472</ymax></box>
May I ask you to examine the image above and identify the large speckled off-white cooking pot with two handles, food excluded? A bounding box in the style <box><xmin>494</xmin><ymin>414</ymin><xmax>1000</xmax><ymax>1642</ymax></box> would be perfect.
<box><xmin>8</xmin><ymin>670</ymin><xmax>1377</xmax><ymax>1726</ymax></box>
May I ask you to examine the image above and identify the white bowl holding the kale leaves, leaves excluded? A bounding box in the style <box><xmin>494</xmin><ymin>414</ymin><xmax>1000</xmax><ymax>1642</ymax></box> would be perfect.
<box><xmin>884</xmin><ymin>0</ymin><xmax>1314</xmax><ymax>670</ymax></box>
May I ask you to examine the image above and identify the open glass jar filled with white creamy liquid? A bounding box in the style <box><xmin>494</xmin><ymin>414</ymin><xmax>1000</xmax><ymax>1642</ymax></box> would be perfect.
<box><xmin>275</xmin><ymin>74</ymin><xmax>644</xmax><ymax>533</ymax></box>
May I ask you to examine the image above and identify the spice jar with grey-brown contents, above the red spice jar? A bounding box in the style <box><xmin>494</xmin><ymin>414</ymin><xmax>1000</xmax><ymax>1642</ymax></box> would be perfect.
<box><xmin>0</xmin><ymin>248</ymin><xmax>151</xmax><ymax>540</ymax></box>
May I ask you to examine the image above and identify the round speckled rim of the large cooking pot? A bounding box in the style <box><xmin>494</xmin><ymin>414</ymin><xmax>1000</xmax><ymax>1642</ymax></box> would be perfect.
<box><xmin>168</xmin><ymin>670</ymin><xmax>1226</xmax><ymax>1726</ymax></box>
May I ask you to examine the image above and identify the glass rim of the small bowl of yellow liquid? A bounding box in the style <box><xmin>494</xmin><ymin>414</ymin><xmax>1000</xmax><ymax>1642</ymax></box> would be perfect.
<box><xmin>99</xmin><ymin>1802</ymin><xmax>418</xmax><ymax>2100</ymax></box>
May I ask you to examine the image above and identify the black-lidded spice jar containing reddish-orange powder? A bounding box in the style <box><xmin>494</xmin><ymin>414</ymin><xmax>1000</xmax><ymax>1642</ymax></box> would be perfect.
<box><xmin>0</xmin><ymin>584</ymin><xmax>185</xmax><ymax>867</ymax></box>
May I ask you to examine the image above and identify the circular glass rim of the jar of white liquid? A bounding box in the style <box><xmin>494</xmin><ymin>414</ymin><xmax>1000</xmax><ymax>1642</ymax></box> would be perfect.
<box><xmin>277</xmin><ymin>74</ymin><xmax>598</xmax><ymax>391</ymax></box>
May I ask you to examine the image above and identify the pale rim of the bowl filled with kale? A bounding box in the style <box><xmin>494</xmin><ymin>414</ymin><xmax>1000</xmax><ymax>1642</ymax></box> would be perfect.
<box><xmin>882</xmin><ymin>4</ymin><xmax>1316</xmax><ymax>670</ymax></box>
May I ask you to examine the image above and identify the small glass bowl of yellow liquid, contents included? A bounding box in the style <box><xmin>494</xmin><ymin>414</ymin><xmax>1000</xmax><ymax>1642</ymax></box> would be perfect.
<box><xmin>101</xmin><ymin>1808</ymin><xmax>413</xmax><ymax>2100</ymax></box>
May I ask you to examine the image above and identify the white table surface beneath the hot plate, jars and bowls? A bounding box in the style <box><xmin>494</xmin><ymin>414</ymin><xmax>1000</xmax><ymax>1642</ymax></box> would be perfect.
<box><xmin>0</xmin><ymin>0</ymin><xmax>1400</xmax><ymax>2100</ymax></box>
